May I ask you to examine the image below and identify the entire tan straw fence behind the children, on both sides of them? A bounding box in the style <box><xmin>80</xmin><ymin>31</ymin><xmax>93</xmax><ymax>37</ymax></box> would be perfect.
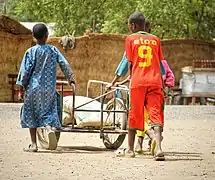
<box><xmin>0</xmin><ymin>14</ymin><xmax>215</xmax><ymax>102</ymax></box>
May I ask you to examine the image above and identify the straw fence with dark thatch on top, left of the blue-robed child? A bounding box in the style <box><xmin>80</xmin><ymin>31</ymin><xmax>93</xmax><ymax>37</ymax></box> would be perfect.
<box><xmin>0</xmin><ymin>16</ymin><xmax>32</xmax><ymax>102</ymax></box>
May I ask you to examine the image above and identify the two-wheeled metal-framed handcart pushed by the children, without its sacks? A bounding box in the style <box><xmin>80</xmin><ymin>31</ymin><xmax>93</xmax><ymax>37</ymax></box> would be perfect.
<box><xmin>37</xmin><ymin>80</ymin><xmax>129</xmax><ymax>149</ymax></box>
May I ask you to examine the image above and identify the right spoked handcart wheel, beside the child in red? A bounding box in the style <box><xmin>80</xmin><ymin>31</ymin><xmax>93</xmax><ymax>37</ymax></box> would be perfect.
<box><xmin>103</xmin><ymin>98</ymin><xmax>127</xmax><ymax>149</ymax></box>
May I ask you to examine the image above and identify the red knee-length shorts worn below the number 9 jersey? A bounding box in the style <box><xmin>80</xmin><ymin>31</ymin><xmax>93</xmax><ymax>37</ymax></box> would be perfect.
<box><xmin>128</xmin><ymin>87</ymin><xmax>164</xmax><ymax>130</ymax></box>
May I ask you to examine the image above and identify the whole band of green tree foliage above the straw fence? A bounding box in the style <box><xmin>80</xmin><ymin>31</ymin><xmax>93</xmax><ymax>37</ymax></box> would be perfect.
<box><xmin>5</xmin><ymin>0</ymin><xmax>215</xmax><ymax>40</ymax></box>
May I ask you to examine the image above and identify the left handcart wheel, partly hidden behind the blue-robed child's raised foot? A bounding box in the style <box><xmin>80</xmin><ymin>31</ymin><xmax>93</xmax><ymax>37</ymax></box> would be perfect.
<box><xmin>37</xmin><ymin>128</ymin><xmax>60</xmax><ymax>149</ymax></box>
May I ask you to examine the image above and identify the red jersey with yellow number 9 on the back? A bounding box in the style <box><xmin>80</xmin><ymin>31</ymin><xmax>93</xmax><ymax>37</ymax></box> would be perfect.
<box><xmin>125</xmin><ymin>32</ymin><xmax>163</xmax><ymax>88</ymax></box>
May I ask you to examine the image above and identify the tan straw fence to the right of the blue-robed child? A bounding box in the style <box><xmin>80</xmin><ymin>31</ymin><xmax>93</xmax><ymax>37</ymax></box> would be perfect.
<box><xmin>48</xmin><ymin>34</ymin><xmax>215</xmax><ymax>95</ymax></box>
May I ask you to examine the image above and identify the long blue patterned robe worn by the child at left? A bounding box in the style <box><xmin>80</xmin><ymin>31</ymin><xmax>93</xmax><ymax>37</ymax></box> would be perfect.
<box><xmin>16</xmin><ymin>44</ymin><xmax>72</xmax><ymax>128</ymax></box>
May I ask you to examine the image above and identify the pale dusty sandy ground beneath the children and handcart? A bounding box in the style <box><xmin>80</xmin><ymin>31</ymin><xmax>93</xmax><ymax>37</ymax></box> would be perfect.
<box><xmin>0</xmin><ymin>104</ymin><xmax>215</xmax><ymax>180</ymax></box>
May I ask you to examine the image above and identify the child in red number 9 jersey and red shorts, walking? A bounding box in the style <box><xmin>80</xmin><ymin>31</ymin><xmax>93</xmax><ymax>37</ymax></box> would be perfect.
<box><xmin>121</xmin><ymin>13</ymin><xmax>165</xmax><ymax>160</ymax></box>
